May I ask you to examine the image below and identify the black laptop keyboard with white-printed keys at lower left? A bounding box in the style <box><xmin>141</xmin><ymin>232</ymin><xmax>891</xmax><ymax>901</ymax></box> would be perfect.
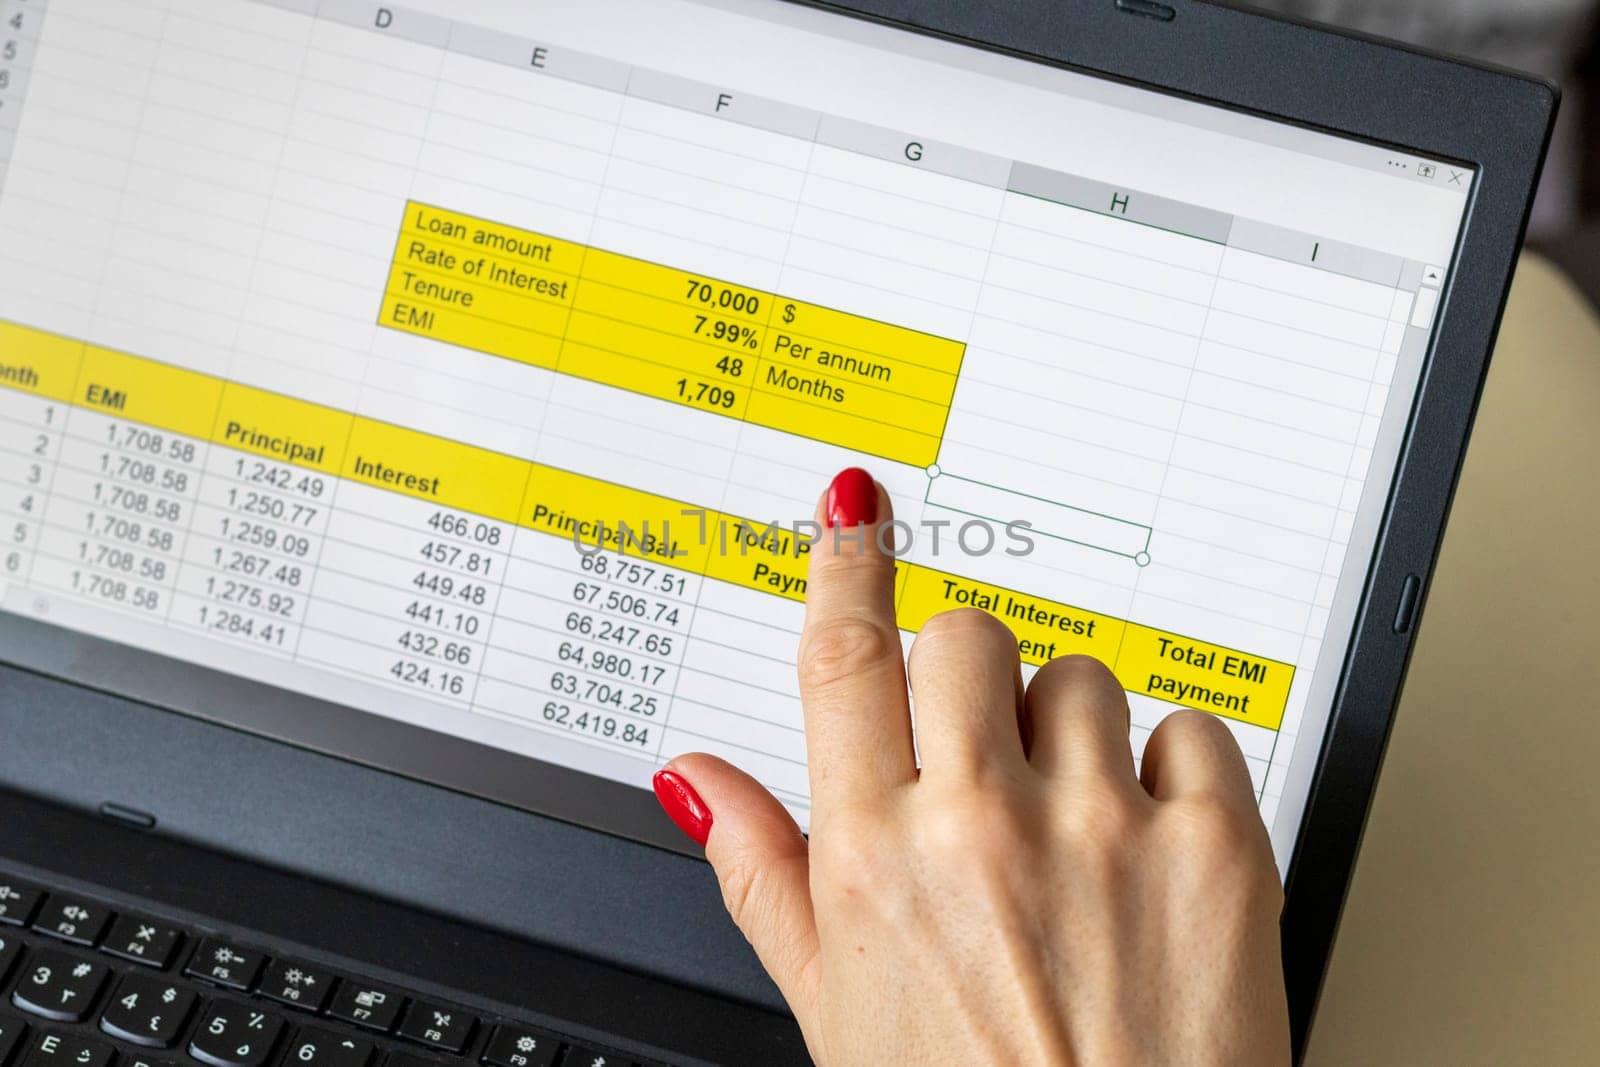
<box><xmin>0</xmin><ymin>875</ymin><xmax>656</xmax><ymax>1067</ymax></box>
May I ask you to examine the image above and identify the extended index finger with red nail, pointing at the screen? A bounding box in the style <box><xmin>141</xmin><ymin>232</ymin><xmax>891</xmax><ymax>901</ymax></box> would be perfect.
<box><xmin>798</xmin><ymin>467</ymin><xmax>917</xmax><ymax>813</ymax></box>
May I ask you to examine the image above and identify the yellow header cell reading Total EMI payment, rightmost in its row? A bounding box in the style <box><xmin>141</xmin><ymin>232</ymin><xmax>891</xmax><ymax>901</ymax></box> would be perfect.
<box><xmin>1115</xmin><ymin>622</ymin><xmax>1294</xmax><ymax>729</ymax></box>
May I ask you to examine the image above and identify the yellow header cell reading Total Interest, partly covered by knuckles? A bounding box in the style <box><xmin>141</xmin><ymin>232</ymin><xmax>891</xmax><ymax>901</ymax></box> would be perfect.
<box><xmin>899</xmin><ymin>563</ymin><xmax>1128</xmax><ymax>665</ymax></box>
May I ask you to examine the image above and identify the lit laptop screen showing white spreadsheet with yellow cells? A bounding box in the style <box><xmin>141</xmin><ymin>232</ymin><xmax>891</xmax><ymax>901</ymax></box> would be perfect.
<box><xmin>0</xmin><ymin>0</ymin><xmax>1474</xmax><ymax>862</ymax></box>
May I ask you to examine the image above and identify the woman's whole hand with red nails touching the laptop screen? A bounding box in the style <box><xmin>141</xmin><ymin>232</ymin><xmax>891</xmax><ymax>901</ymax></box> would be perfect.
<box><xmin>656</xmin><ymin>470</ymin><xmax>1290</xmax><ymax>1067</ymax></box>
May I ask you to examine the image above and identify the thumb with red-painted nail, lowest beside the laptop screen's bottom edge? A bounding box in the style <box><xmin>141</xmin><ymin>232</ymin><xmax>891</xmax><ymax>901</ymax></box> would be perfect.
<box><xmin>654</xmin><ymin>752</ymin><xmax>818</xmax><ymax>1029</ymax></box>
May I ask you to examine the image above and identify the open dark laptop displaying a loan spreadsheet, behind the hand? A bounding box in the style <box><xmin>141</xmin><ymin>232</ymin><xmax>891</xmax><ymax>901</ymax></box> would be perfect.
<box><xmin>0</xmin><ymin>0</ymin><xmax>1555</xmax><ymax>1067</ymax></box>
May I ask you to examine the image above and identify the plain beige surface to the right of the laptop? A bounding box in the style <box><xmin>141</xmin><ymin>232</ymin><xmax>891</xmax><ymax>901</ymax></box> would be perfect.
<box><xmin>1307</xmin><ymin>258</ymin><xmax>1600</xmax><ymax>1067</ymax></box>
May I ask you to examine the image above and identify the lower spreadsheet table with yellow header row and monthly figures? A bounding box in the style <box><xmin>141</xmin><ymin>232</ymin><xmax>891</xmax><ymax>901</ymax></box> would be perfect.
<box><xmin>0</xmin><ymin>325</ymin><xmax>1293</xmax><ymax>798</ymax></box>
